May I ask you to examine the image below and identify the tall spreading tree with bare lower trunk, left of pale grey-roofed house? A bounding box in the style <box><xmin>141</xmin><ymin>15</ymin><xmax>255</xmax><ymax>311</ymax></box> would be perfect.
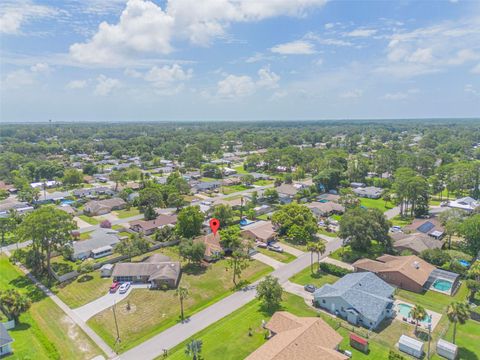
<box><xmin>17</xmin><ymin>205</ymin><xmax>76</xmax><ymax>279</ymax></box>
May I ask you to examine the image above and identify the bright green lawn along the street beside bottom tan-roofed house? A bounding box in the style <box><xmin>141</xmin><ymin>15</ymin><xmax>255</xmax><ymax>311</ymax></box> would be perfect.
<box><xmin>162</xmin><ymin>293</ymin><xmax>316</xmax><ymax>360</ymax></box>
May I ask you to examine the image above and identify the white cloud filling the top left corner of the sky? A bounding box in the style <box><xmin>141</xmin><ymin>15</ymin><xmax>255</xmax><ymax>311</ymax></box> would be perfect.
<box><xmin>0</xmin><ymin>1</ymin><xmax>59</xmax><ymax>35</ymax></box>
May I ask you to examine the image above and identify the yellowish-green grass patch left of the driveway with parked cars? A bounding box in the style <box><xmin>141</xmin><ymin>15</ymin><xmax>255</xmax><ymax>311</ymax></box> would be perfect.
<box><xmin>52</xmin><ymin>271</ymin><xmax>112</xmax><ymax>308</ymax></box>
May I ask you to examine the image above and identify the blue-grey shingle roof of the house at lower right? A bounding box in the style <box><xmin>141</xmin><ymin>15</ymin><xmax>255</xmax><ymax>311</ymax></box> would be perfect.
<box><xmin>314</xmin><ymin>272</ymin><xmax>395</xmax><ymax>321</ymax></box>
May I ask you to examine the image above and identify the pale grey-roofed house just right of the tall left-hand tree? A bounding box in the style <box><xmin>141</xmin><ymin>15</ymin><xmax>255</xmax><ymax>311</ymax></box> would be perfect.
<box><xmin>72</xmin><ymin>228</ymin><xmax>120</xmax><ymax>261</ymax></box>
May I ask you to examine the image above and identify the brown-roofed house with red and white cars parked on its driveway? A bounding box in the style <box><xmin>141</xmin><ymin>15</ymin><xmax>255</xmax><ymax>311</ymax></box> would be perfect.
<box><xmin>112</xmin><ymin>254</ymin><xmax>181</xmax><ymax>289</ymax></box>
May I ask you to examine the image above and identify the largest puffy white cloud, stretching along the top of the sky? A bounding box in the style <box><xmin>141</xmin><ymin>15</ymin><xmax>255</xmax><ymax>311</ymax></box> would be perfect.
<box><xmin>70</xmin><ymin>0</ymin><xmax>326</xmax><ymax>64</ymax></box>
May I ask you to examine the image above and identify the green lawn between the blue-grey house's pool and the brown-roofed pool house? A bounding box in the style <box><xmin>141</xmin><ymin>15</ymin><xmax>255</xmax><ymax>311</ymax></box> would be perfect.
<box><xmin>395</xmin><ymin>283</ymin><xmax>468</xmax><ymax>314</ymax></box>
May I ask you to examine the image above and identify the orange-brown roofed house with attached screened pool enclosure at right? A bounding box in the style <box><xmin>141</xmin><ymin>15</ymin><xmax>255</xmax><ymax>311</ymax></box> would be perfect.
<box><xmin>352</xmin><ymin>255</ymin><xmax>459</xmax><ymax>294</ymax></box>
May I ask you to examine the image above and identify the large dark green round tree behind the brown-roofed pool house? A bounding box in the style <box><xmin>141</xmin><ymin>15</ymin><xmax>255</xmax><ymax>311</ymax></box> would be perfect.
<box><xmin>338</xmin><ymin>208</ymin><xmax>391</xmax><ymax>252</ymax></box>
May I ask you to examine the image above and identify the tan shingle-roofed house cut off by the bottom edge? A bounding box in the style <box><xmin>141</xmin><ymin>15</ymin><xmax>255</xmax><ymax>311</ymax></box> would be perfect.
<box><xmin>246</xmin><ymin>311</ymin><xmax>348</xmax><ymax>360</ymax></box>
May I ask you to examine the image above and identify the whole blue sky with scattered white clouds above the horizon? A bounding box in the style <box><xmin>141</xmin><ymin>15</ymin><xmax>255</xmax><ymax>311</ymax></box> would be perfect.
<box><xmin>0</xmin><ymin>0</ymin><xmax>480</xmax><ymax>122</ymax></box>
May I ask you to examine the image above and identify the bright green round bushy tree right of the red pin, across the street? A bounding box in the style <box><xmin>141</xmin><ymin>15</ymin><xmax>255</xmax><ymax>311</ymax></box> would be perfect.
<box><xmin>272</xmin><ymin>203</ymin><xmax>318</xmax><ymax>244</ymax></box>
